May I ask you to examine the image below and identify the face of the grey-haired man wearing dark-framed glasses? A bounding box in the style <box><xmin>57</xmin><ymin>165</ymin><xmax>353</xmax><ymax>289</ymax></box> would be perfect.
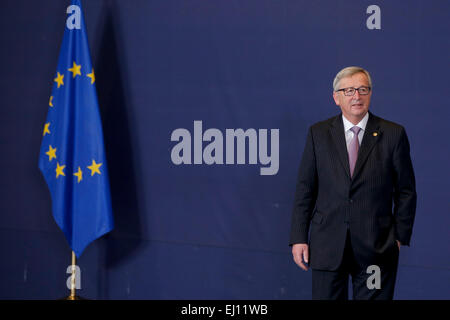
<box><xmin>333</xmin><ymin>73</ymin><xmax>372</xmax><ymax>124</ymax></box>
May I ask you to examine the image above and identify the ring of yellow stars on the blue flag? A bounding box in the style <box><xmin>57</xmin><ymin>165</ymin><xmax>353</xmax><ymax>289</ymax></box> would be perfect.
<box><xmin>42</xmin><ymin>61</ymin><xmax>103</xmax><ymax>183</ymax></box>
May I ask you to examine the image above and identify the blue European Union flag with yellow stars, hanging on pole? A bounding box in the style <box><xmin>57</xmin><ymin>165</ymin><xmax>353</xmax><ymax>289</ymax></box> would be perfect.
<box><xmin>39</xmin><ymin>0</ymin><xmax>113</xmax><ymax>257</ymax></box>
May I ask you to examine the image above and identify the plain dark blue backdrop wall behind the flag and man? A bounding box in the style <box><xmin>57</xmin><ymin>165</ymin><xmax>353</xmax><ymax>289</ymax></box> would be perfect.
<box><xmin>0</xmin><ymin>0</ymin><xmax>450</xmax><ymax>299</ymax></box>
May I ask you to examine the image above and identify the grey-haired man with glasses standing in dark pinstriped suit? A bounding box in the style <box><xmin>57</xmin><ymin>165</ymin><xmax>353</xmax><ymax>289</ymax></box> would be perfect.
<box><xmin>290</xmin><ymin>67</ymin><xmax>417</xmax><ymax>300</ymax></box>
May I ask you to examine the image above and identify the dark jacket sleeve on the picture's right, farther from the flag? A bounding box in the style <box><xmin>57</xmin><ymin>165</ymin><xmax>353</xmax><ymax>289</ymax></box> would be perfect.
<box><xmin>393</xmin><ymin>128</ymin><xmax>417</xmax><ymax>246</ymax></box>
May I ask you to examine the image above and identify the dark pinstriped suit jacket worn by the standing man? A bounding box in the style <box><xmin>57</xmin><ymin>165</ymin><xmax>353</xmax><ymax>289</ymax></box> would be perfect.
<box><xmin>290</xmin><ymin>112</ymin><xmax>417</xmax><ymax>270</ymax></box>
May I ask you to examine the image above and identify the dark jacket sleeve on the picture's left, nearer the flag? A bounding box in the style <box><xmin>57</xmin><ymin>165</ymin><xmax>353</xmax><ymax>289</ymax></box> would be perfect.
<box><xmin>289</xmin><ymin>128</ymin><xmax>318</xmax><ymax>245</ymax></box>
